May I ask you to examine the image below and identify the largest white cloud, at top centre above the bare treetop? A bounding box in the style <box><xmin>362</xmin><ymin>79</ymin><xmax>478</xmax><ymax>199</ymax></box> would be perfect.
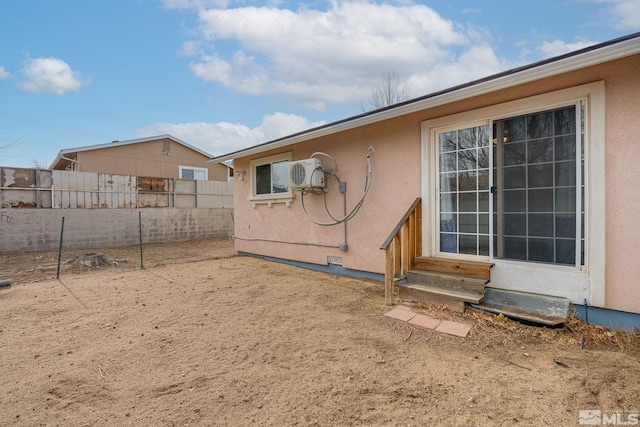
<box><xmin>180</xmin><ymin>0</ymin><xmax>505</xmax><ymax>109</ymax></box>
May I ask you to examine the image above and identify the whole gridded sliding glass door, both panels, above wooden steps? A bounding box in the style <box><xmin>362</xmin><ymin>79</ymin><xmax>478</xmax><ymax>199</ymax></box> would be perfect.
<box><xmin>436</xmin><ymin>104</ymin><xmax>583</xmax><ymax>266</ymax></box>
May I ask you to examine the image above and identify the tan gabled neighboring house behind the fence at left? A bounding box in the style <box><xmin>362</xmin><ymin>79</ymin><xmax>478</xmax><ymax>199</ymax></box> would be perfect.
<box><xmin>49</xmin><ymin>135</ymin><xmax>233</xmax><ymax>181</ymax></box>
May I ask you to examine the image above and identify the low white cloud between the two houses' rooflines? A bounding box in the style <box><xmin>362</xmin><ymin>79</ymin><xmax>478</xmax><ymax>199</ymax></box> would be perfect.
<box><xmin>136</xmin><ymin>113</ymin><xmax>324</xmax><ymax>155</ymax></box>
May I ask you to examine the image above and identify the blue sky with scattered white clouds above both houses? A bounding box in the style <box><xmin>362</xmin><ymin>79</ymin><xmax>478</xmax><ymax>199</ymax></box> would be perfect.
<box><xmin>0</xmin><ymin>0</ymin><xmax>640</xmax><ymax>167</ymax></box>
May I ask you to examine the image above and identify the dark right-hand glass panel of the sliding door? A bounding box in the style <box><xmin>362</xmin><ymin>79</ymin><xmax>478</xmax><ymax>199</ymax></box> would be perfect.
<box><xmin>493</xmin><ymin>106</ymin><xmax>579</xmax><ymax>264</ymax></box>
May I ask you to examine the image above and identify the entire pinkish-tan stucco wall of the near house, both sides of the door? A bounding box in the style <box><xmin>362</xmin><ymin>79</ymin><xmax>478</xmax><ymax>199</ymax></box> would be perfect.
<box><xmin>235</xmin><ymin>55</ymin><xmax>640</xmax><ymax>312</ymax></box>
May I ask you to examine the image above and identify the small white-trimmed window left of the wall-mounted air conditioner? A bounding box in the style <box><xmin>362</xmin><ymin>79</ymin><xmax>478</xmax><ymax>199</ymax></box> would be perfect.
<box><xmin>249</xmin><ymin>152</ymin><xmax>293</xmax><ymax>207</ymax></box>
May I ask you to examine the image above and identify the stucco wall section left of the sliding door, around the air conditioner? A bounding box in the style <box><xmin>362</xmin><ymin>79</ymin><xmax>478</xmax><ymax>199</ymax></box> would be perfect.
<box><xmin>234</xmin><ymin>121</ymin><xmax>421</xmax><ymax>273</ymax></box>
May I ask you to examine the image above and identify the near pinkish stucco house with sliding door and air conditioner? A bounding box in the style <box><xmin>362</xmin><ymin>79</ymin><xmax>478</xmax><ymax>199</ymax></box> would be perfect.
<box><xmin>212</xmin><ymin>33</ymin><xmax>640</xmax><ymax>324</ymax></box>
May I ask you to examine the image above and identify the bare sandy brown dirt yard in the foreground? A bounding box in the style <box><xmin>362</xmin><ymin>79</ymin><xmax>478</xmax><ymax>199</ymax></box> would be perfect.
<box><xmin>0</xmin><ymin>241</ymin><xmax>640</xmax><ymax>426</ymax></box>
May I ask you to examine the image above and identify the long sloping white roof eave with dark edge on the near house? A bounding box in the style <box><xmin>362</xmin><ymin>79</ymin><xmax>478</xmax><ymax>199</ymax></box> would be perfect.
<box><xmin>210</xmin><ymin>32</ymin><xmax>640</xmax><ymax>163</ymax></box>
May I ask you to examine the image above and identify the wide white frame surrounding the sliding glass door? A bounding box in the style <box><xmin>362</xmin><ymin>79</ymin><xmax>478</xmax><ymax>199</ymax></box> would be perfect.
<box><xmin>421</xmin><ymin>81</ymin><xmax>605</xmax><ymax>307</ymax></box>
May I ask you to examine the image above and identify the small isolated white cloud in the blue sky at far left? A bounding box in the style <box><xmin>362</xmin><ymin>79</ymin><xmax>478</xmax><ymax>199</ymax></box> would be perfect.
<box><xmin>21</xmin><ymin>58</ymin><xmax>90</xmax><ymax>95</ymax></box>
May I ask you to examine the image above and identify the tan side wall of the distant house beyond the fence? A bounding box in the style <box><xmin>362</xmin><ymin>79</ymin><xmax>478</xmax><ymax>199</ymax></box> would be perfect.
<box><xmin>77</xmin><ymin>139</ymin><xmax>228</xmax><ymax>181</ymax></box>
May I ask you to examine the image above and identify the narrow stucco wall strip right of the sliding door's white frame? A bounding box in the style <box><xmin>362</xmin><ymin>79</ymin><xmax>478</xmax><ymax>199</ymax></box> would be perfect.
<box><xmin>605</xmin><ymin>56</ymin><xmax>640</xmax><ymax>311</ymax></box>
